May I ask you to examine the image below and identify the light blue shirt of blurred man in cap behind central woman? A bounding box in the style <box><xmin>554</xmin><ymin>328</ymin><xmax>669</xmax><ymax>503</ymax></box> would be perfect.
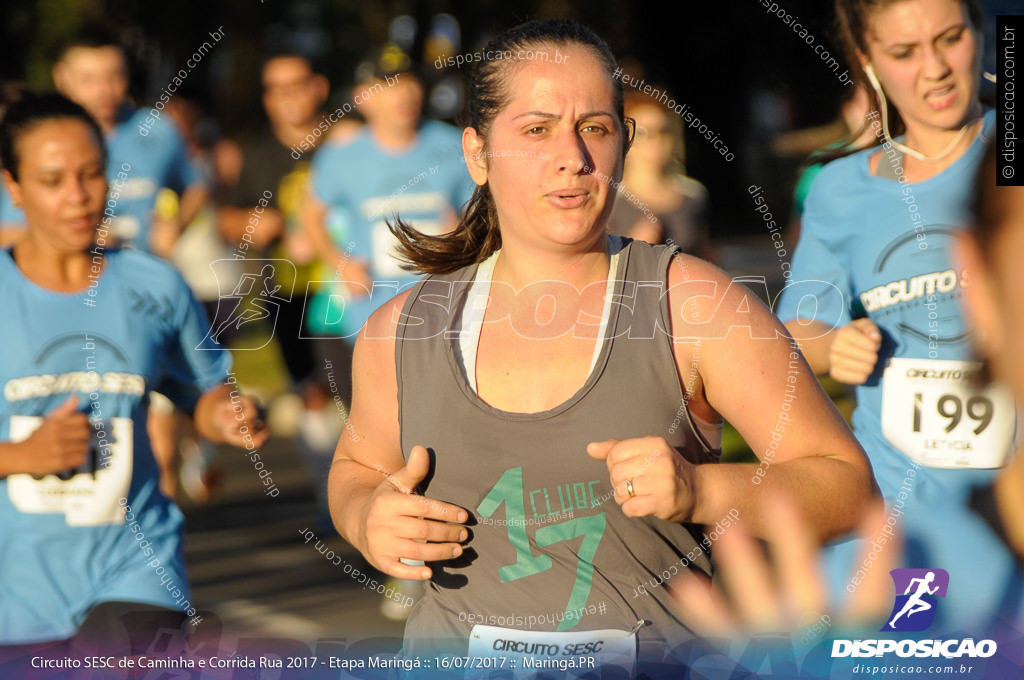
<box><xmin>306</xmin><ymin>121</ymin><xmax>475</xmax><ymax>337</ymax></box>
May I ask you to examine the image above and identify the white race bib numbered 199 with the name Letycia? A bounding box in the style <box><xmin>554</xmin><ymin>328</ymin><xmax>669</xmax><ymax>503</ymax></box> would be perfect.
<box><xmin>882</xmin><ymin>358</ymin><xmax>1017</xmax><ymax>468</ymax></box>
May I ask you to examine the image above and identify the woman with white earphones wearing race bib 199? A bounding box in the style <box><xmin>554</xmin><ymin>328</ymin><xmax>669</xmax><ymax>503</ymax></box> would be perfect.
<box><xmin>778</xmin><ymin>0</ymin><xmax>1017</xmax><ymax>517</ymax></box>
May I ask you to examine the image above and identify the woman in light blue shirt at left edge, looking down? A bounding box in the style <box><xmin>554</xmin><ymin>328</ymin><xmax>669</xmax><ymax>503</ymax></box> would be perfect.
<box><xmin>0</xmin><ymin>94</ymin><xmax>266</xmax><ymax>650</ymax></box>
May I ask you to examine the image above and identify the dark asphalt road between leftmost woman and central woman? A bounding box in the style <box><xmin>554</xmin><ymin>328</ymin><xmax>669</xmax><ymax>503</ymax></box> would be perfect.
<box><xmin>185</xmin><ymin>438</ymin><xmax>404</xmax><ymax>649</ymax></box>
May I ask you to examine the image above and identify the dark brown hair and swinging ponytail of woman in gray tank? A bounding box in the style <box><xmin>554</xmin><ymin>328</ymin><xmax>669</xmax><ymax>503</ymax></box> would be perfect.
<box><xmin>388</xmin><ymin>19</ymin><xmax>629</xmax><ymax>273</ymax></box>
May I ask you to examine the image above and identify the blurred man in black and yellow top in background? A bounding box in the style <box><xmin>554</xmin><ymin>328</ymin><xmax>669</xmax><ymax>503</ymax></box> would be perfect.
<box><xmin>219</xmin><ymin>53</ymin><xmax>341</xmax><ymax>518</ymax></box>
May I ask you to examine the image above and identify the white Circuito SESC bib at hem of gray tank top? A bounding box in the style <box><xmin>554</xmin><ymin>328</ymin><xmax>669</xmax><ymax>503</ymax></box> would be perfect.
<box><xmin>469</xmin><ymin>625</ymin><xmax>637</xmax><ymax>678</ymax></box>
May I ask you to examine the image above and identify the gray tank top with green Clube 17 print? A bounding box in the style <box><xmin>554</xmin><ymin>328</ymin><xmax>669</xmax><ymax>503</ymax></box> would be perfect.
<box><xmin>395</xmin><ymin>240</ymin><xmax>719</xmax><ymax>656</ymax></box>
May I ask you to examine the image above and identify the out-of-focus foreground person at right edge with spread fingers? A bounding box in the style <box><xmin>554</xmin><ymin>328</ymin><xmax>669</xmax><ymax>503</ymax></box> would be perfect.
<box><xmin>673</xmin><ymin>143</ymin><xmax>1024</xmax><ymax>677</ymax></box>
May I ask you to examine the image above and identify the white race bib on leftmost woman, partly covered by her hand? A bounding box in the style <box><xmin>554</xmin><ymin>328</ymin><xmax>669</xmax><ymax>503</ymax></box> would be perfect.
<box><xmin>7</xmin><ymin>416</ymin><xmax>132</xmax><ymax>526</ymax></box>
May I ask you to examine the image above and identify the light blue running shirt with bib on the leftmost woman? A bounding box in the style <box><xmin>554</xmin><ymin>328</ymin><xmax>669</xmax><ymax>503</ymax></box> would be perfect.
<box><xmin>0</xmin><ymin>249</ymin><xmax>230</xmax><ymax>644</ymax></box>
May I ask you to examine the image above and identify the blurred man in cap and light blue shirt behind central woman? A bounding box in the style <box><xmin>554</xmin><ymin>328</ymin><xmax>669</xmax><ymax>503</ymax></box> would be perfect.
<box><xmin>306</xmin><ymin>45</ymin><xmax>473</xmax><ymax>620</ymax></box>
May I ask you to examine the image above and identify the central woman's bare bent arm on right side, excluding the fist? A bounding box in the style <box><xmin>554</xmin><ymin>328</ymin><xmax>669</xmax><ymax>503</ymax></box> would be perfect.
<box><xmin>669</xmin><ymin>255</ymin><xmax>878</xmax><ymax>540</ymax></box>
